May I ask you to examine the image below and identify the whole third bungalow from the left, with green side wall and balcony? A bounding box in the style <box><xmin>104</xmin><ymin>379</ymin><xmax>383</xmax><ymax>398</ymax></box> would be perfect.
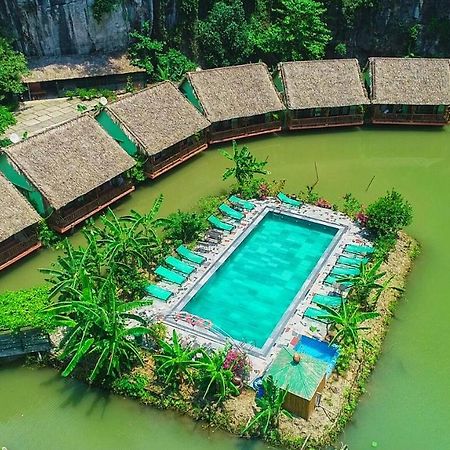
<box><xmin>96</xmin><ymin>81</ymin><xmax>210</xmax><ymax>178</ymax></box>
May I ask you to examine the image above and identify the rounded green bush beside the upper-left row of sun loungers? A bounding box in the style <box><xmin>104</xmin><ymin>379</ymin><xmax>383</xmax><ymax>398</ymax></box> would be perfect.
<box><xmin>164</xmin><ymin>210</ymin><xmax>207</xmax><ymax>244</ymax></box>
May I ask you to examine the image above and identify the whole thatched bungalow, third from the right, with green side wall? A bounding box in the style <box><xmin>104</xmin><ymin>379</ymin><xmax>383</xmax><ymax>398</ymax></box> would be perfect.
<box><xmin>180</xmin><ymin>63</ymin><xmax>284</xmax><ymax>143</ymax></box>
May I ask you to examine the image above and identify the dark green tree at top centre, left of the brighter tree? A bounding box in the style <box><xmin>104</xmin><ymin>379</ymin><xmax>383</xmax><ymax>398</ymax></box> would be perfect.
<box><xmin>198</xmin><ymin>0</ymin><xmax>251</xmax><ymax>67</ymax></box>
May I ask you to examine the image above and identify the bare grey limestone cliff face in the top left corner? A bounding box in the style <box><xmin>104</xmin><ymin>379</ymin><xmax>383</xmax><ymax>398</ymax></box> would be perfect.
<box><xmin>0</xmin><ymin>0</ymin><xmax>153</xmax><ymax>56</ymax></box>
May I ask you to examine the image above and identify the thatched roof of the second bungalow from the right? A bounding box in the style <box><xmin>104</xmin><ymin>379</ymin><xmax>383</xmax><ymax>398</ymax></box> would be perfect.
<box><xmin>279</xmin><ymin>59</ymin><xmax>369</xmax><ymax>109</ymax></box>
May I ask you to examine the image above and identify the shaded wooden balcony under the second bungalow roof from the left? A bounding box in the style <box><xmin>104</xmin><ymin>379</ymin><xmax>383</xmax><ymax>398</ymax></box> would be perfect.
<box><xmin>49</xmin><ymin>178</ymin><xmax>134</xmax><ymax>233</ymax></box>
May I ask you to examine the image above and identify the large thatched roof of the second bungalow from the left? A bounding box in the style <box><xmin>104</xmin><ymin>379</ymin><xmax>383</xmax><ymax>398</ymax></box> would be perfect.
<box><xmin>5</xmin><ymin>115</ymin><xmax>135</xmax><ymax>209</ymax></box>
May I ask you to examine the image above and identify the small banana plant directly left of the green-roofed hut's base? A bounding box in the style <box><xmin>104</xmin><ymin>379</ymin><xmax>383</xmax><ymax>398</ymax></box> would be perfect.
<box><xmin>241</xmin><ymin>376</ymin><xmax>292</xmax><ymax>436</ymax></box>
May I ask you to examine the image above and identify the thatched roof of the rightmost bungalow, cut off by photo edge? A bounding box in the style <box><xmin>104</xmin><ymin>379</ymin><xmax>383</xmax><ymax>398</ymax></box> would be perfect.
<box><xmin>369</xmin><ymin>58</ymin><xmax>450</xmax><ymax>105</ymax></box>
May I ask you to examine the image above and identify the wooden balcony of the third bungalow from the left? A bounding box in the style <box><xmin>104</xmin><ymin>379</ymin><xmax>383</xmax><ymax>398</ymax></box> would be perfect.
<box><xmin>145</xmin><ymin>135</ymin><xmax>208</xmax><ymax>180</ymax></box>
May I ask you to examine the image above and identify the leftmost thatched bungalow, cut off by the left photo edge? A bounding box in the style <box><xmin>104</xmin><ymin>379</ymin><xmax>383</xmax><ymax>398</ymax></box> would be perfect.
<box><xmin>0</xmin><ymin>173</ymin><xmax>41</xmax><ymax>270</ymax></box>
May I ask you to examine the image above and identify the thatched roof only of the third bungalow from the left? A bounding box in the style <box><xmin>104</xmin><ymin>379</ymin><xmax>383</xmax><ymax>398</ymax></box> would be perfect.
<box><xmin>107</xmin><ymin>81</ymin><xmax>210</xmax><ymax>155</ymax></box>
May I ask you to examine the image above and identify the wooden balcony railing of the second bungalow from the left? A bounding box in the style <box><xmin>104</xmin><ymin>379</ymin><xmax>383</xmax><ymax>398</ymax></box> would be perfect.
<box><xmin>49</xmin><ymin>183</ymin><xmax>132</xmax><ymax>233</ymax></box>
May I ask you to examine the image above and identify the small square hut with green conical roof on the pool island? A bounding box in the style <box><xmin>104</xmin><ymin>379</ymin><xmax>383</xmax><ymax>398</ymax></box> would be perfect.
<box><xmin>265</xmin><ymin>348</ymin><xmax>328</xmax><ymax>420</ymax></box>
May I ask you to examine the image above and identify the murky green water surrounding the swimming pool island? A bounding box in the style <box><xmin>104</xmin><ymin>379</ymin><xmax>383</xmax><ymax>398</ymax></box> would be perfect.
<box><xmin>0</xmin><ymin>127</ymin><xmax>450</xmax><ymax>450</ymax></box>
